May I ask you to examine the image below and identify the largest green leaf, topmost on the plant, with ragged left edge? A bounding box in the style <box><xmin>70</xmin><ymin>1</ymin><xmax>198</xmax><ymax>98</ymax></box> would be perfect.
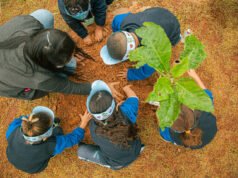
<box><xmin>129</xmin><ymin>22</ymin><xmax>171</xmax><ymax>72</ymax></box>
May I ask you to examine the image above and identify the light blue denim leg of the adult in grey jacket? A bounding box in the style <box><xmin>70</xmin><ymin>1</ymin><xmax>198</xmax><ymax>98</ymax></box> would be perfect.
<box><xmin>30</xmin><ymin>9</ymin><xmax>54</xmax><ymax>29</ymax></box>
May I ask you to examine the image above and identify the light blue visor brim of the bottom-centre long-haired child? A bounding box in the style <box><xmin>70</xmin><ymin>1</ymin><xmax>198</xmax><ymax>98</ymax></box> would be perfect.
<box><xmin>86</xmin><ymin>80</ymin><xmax>112</xmax><ymax>112</ymax></box>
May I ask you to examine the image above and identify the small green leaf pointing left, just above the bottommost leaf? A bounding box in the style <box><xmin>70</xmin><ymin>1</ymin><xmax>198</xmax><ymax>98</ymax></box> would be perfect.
<box><xmin>146</xmin><ymin>77</ymin><xmax>174</xmax><ymax>102</ymax></box>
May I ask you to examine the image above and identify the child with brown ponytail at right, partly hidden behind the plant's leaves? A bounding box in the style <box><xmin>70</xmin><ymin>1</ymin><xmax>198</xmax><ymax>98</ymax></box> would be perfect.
<box><xmin>159</xmin><ymin>70</ymin><xmax>217</xmax><ymax>149</ymax></box>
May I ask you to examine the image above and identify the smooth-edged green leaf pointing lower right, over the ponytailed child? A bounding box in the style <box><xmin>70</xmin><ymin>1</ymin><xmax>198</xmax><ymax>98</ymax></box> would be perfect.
<box><xmin>176</xmin><ymin>78</ymin><xmax>214</xmax><ymax>112</ymax></box>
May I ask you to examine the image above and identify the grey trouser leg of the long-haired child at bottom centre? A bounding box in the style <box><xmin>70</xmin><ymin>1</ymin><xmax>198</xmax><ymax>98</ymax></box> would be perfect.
<box><xmin>78</xmin><ymin>144</ymin><xmax>111</xmax><ymax>168</ymax></box>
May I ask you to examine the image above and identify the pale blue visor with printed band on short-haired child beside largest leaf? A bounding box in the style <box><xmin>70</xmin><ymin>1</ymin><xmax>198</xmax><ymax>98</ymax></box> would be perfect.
<box><xmin>100</xmin><ymin>31</ymin><xmax>136</xmax><ymax>65</ymax></box>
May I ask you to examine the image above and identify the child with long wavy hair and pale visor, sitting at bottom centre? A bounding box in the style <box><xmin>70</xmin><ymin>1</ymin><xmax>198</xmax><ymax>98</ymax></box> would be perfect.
<box><xmin>78</xmin><ymin>80</ymin><xmax>144</xmax><ymax>170</ymax></box>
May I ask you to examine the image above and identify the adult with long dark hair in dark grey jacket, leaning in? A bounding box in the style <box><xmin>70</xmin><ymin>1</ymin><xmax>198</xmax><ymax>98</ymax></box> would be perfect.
<box><xmin>0</xmin><ymin>9</ymin><xmax>95</xmax><ymax>100</ymax></box>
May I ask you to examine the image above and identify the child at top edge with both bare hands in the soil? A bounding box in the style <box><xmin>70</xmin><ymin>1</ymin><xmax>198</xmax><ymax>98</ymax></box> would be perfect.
<box><xmin>58</xmin><ymin>0</ymin><xmax>113</xmax><ymax>45</ymax></box>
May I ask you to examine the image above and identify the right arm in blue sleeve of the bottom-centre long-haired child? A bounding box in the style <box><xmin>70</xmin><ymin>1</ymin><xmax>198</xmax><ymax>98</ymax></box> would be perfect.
<box><xmin>120</xmin><ymin>85</ymin><xmax>139</xmax><ymax>124</ymax></box>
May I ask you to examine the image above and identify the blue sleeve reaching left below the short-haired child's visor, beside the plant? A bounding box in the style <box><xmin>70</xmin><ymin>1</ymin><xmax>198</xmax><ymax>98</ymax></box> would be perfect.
<box><xmin>127</xmin><ymin>64</ymin><xmax>155</xmax><ymax>81</ymax></box>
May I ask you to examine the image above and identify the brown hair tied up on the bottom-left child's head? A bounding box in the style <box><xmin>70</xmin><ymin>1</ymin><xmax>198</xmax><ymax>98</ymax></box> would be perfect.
<box><xmin>22</xmin><ymin>112</ymin><xmax>52</xmax><ymax>137</ymax></box>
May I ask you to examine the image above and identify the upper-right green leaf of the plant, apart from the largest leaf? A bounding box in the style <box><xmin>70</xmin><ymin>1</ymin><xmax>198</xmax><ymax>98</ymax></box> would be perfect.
<box><xmin>180</xmin><ymin>35</ymin><xmax>206</xmax><ymax>69</ymax></box>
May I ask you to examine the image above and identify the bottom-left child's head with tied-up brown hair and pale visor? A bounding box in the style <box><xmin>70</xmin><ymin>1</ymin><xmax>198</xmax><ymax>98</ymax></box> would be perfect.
<box><xmin>21</xmin><ymin>106</ymin><xmax>54</xmax><ymax>144</ymax></box>
